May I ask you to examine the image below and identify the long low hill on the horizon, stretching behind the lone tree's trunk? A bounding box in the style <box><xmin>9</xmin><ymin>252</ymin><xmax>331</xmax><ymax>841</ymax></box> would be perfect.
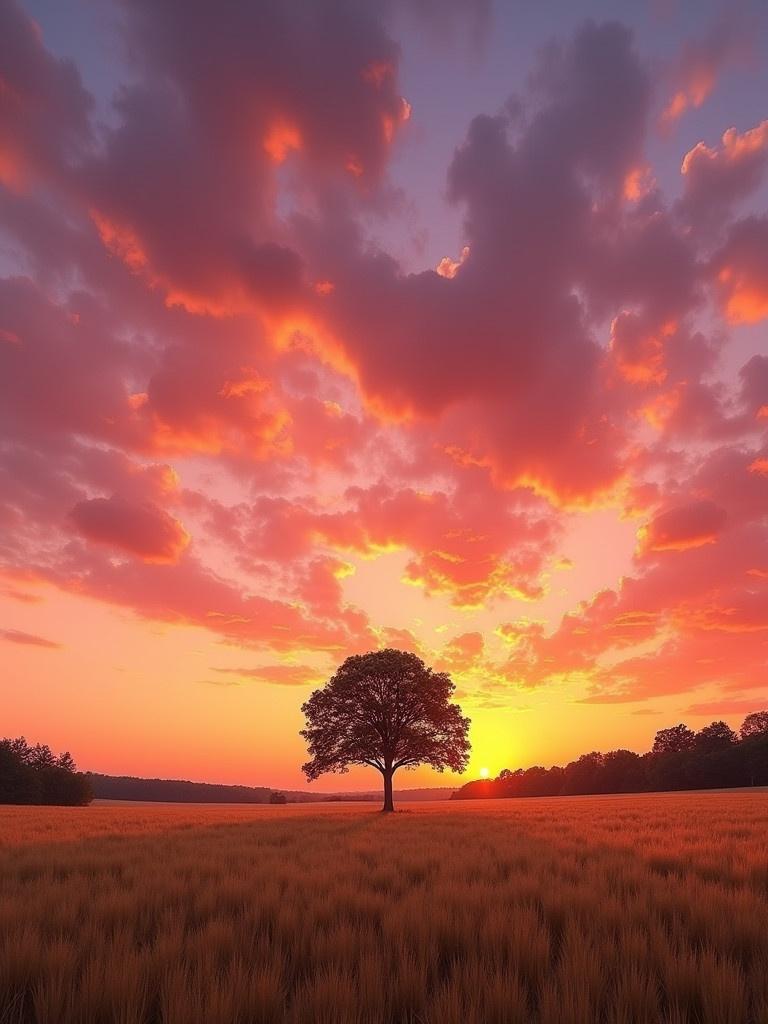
<box><xmin>87</xmin><ymin>772</ymin><xmax>455</xmax><ymax>804</ymax></box>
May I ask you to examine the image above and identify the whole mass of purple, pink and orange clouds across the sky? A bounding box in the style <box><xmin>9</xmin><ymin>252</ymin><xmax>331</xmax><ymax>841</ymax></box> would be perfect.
<box><xmin>0</xmin><ymin>9</ymin><xmax>768</xmax><ymax>729</ymax></box>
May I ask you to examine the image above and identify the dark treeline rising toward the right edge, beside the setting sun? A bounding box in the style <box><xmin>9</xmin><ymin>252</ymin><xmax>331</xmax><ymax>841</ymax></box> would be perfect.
<box><xmin>452</xmin><ymin>711</ymin><xmax>768</xmax><ymax>800</ymax></box>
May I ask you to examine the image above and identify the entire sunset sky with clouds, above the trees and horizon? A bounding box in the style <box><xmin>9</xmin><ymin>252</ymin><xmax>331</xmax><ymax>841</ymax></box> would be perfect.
<box><xmin>0</xmin><ymin>0</ymin><xmax>768</xmax><ymax>791</ymax></box>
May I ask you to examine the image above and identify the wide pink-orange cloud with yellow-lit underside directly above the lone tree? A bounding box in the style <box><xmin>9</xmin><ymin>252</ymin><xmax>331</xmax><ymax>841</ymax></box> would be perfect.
<box><xmin>236</xmin><ymin>470</ymin><xmax>557</xmax><ymax>607</ymax></box>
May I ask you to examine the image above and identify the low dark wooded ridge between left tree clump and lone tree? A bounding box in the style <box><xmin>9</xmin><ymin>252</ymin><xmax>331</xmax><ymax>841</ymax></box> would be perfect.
<box><xmin>88</xmin><ymin>772</ymin><xmax>327</xmax><ymax>804</ymax></box>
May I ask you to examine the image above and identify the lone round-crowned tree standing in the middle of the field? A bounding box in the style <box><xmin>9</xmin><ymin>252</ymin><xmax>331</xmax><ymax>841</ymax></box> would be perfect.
<box><xmin>301</xmin><ymin>648</ymin><xmax>470</xmax><ymax>811</ymax></box>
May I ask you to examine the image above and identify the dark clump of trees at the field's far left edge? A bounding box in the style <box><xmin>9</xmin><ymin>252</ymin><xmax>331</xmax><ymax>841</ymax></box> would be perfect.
<box><xmin>0</xmin><ymin>736</ymin><xmax>93</xmax><ymax>807</ymax></box>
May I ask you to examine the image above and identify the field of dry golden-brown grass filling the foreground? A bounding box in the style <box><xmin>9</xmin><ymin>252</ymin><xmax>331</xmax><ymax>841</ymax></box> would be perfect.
<box><xmin>0</xmin><ymin>793</ymin><xmax>768</xmax><ymax>1024</ymax></box>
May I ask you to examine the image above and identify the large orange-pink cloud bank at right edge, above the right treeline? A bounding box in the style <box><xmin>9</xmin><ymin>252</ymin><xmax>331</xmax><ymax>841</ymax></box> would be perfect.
<box><xmin>487</xmin><ymin>434</ymin><xmax>768</xmax><ymax>703</ymax></box>
